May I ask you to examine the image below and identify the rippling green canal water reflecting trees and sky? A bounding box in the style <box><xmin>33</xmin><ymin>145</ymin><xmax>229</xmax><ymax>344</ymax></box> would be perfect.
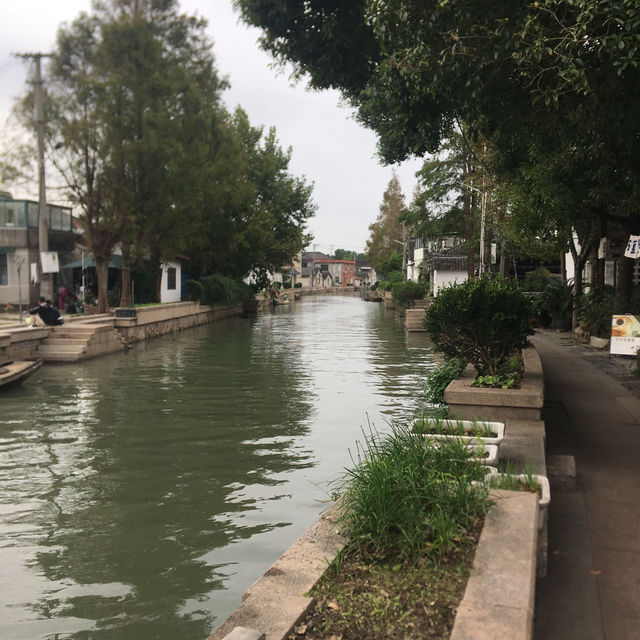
<box><xmin>0</xmin><ymin>296</ymin><xmax>434</xmax><ymax>640</ymax></box>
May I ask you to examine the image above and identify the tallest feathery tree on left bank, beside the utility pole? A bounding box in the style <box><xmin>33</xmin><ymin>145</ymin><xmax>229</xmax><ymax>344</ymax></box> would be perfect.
<box><xmin>44</xmin><ymin>0</ymin><xmax>224</xmax><ymax>311</ymax></box>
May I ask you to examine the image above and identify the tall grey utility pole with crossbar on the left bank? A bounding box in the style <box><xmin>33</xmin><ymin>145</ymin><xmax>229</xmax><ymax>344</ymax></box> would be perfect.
<box><xmin>15</xmin><ymin>53</ymin><xmax>53</xmax><ymax>299</ymax></box>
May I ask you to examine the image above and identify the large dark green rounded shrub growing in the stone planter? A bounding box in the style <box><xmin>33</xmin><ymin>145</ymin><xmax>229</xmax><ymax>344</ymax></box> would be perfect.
<box><xmin>424</xmin><ymin>277</ymin><xmax>533</xmax><ymax>375</ymax></box>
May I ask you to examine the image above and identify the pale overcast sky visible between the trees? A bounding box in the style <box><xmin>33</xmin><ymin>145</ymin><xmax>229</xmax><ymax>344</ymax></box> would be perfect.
<box><xmin>0</xmin><ymin>0</ymin><xmax>421</xmax><ymax>253</ymax></box>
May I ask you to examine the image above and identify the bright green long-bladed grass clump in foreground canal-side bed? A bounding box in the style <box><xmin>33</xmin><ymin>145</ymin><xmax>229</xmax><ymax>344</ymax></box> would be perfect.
<box><xmin>341</xmin><ymin>425</ymin><xmax>488</xmax><ymax>560</ymax></box>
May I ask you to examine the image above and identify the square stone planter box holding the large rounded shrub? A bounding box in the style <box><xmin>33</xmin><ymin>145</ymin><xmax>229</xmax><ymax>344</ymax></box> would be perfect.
<box><xmin>444</xmin><ymin>347</ymin><xmax>544</xmax><ymax>422</ymax></box>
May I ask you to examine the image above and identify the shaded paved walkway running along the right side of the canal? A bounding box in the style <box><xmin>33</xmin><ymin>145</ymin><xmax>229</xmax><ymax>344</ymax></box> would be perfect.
<box><xmin>532</xmin><ymin>331</ymin><xmax>640</xmax><ymax>640</ymax></box>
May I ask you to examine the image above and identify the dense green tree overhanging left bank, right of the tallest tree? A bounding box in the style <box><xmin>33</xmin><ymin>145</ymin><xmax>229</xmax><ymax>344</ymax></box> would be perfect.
<box><xmin>191</xmin><ymin>108</ymin><xmax>316</xmax><ymax>277</ymax></box>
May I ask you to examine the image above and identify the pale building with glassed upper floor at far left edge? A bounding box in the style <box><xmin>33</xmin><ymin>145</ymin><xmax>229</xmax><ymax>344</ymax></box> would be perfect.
<box><xmin>0</xmin><ymin>192</ymin><xmax>77</xmax><ymax>306</ymax></box>
